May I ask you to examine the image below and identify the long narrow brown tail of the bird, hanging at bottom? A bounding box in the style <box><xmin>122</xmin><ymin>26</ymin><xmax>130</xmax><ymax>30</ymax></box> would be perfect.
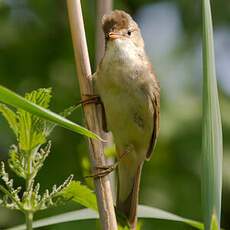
<box><xmin>116</xmin><ymin>162</ymin><xmax>143</xmax><ymax>230</ymax></box>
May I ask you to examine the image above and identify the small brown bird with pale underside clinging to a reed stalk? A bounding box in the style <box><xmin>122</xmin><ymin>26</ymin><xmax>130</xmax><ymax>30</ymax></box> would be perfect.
<box><xmin>93</xmin><ymin>10</ymin><xmax>160</xmax><ymax>229</ymax></box>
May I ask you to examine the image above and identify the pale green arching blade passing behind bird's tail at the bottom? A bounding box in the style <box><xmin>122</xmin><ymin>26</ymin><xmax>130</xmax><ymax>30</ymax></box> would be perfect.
<box><xmin>8</xmin><ymin>205</ymin><xmax>204</xmax><ymax>230</ymax></box>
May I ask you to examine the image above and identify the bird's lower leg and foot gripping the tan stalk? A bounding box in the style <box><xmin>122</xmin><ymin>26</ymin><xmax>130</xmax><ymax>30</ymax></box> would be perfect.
<box><xmin>85</xmin><ymin>148</ymin><xmax>129</xmax><ymax>178</ymax></box>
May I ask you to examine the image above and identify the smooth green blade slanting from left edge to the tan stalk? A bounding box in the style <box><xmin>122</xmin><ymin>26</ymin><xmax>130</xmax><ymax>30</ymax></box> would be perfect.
<box><xmin>0</xmin><ymin>85</ymin><xmax>102</xmax><ymax>140</ymax></box>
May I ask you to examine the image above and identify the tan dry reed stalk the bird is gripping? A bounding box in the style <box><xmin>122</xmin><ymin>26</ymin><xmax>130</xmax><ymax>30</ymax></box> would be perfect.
<box><xmin>67</xmin><ymin>0</ymin><xmax>117</xmax><ymax>230</ymax></box>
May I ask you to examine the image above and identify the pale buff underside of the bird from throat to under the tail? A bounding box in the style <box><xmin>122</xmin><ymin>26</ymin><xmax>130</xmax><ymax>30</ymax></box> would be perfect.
<box><xmin>94</xmin><ymin>39</ymin><xmax>155</xmax><ymax>200</ymax></box>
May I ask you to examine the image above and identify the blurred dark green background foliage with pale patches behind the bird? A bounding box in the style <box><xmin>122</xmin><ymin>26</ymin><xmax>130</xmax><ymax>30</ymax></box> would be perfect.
<box><xmin>0</xmin><ymin>0</ymin><xmax>230</xmax><ymax>230</ymax></box>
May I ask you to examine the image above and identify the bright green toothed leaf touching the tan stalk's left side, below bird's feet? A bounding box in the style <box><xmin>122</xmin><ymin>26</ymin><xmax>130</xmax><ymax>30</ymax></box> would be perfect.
<box><xmin>60</xmin><ymin>181</ymin><xmax>97</xmax><ymax>210</ymax></box>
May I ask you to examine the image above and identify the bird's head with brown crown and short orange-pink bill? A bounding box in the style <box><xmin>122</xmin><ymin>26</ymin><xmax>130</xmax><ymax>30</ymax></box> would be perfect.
<box><xmin>102</xmin><ymin>10</ymin><xmax>144</xmax><ymax>48</ymax></box>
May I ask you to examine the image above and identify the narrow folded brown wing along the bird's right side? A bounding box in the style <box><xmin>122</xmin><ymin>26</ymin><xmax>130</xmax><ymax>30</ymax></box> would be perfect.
<box><xmin>146</xmin><ymin>72</ymin><xmax>160</xmax><ymax>160</ymax></box>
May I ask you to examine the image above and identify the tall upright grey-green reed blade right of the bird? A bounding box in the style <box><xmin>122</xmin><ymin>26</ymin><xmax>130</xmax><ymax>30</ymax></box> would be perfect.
<box><xmin>202</xmin><ymin>0</ymin><xmax>223</xmax><ymax>230</ymax></box>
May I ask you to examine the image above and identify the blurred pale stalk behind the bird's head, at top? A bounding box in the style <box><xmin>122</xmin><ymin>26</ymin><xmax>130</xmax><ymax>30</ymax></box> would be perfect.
<box><xmin>95</xmin><ymin>0</ymin><xmax>113</xmax><ymax>65</ymax></box>
